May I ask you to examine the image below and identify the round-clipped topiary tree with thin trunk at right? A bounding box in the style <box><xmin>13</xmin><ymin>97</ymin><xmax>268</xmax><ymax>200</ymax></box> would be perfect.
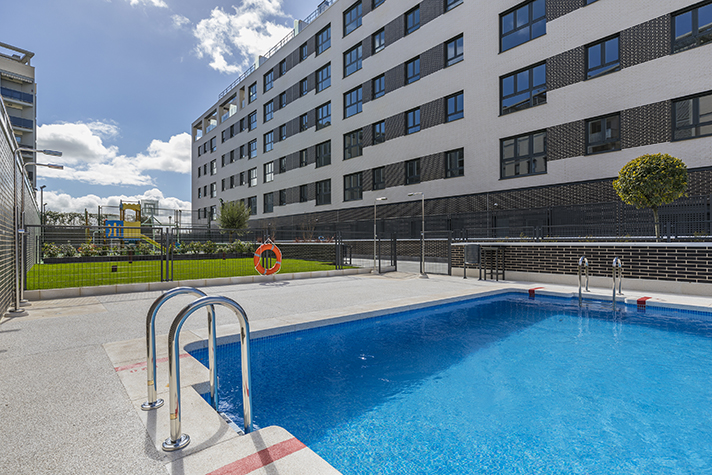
<box><xmin>613</xmin><ymin>153</ymin><xmax>687</xmax><ymax>240</ymax></box>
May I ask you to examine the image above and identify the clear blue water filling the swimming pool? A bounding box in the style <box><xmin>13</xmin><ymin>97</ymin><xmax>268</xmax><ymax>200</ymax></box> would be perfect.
<box><xmin>192</xmin><ymin>294</ymin><xmax>712</xmax><ymax>475</ymax></box>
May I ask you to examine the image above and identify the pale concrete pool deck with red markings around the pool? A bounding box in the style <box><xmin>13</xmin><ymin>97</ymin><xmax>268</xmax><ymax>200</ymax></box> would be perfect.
<box><xmin>0</xmin><ymin>273</ymin><xmax>712</xmax><ymax>475</ymax></box>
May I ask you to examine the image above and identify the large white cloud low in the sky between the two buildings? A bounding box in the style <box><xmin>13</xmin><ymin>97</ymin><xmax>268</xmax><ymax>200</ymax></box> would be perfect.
<box><xmin>37</xmin><ymin>122</ymin><xmax>190</xmax><ymax>186</ymax></box>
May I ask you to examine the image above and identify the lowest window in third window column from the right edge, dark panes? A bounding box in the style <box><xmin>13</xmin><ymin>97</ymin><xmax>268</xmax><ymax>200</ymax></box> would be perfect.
<box><xmin>500</xmin><ymin>132</ymin><xmax>546</xmax><ymax>178</ymax></box>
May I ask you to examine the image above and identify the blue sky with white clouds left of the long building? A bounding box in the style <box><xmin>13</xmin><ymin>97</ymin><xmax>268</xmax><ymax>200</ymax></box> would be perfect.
<box><xmin>0</xmin><ymin>0</ymin><xmax>318</xmax><ymax>220</ymax></box>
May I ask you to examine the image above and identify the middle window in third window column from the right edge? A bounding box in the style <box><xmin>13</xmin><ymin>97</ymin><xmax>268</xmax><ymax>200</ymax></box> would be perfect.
<box><xmin>501</xmin><ymin>64</ymin><xmax>546</xmax><ymax>115</ymax></box>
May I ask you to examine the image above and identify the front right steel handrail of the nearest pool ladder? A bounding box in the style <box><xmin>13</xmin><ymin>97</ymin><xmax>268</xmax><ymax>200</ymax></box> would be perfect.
<box><xmin>163</xmin><ymin>296</ymin><xmax>252</xmax><ymax>452</ymax></box>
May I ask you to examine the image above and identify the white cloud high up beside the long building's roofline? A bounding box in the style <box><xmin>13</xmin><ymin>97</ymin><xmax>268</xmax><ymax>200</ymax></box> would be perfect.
<box><xmin>193</xmin><ymin>0</ymin><xmax>292</xmax><ymax>73</ymax></box>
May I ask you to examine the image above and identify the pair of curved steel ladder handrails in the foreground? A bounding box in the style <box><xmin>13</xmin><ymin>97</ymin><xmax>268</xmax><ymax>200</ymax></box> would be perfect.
<box><xmin>141</xmin><ymin>287</ymin><xmax>252</xmax><ymax>452</ymax></box>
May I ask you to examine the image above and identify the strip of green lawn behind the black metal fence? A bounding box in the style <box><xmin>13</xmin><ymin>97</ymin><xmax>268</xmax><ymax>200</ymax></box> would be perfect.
<box><xmin>26</xmin><ymin>257</ymin><xmax>346</xmax><ymax>290</ymax></box>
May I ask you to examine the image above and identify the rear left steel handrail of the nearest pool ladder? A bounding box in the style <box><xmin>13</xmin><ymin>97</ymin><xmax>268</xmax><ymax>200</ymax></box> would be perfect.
<box><xmin>141</xmin><ymin>287</ymin><xmax>218</xmax><ymax>411</ymax></box>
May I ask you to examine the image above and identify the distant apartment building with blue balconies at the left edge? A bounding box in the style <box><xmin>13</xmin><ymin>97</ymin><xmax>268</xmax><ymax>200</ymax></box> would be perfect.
<box><xmin>0</xmin><ymin>43</ymin><xmax>37</xmax><ymax>186</ymax></box>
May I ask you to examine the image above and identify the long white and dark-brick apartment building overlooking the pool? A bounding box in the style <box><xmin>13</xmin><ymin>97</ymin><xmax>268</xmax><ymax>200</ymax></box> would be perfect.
<box><xmin>191</xmin><ymin>0</ymin><xmax>712</xmax><ymax>230</ymax></box>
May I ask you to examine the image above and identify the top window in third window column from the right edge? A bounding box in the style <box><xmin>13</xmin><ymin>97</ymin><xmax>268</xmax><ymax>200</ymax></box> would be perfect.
<box><xmin>499</xmin><ymin>0</ymin><xmax>546</xmax><ymax>51</ymax></box>
